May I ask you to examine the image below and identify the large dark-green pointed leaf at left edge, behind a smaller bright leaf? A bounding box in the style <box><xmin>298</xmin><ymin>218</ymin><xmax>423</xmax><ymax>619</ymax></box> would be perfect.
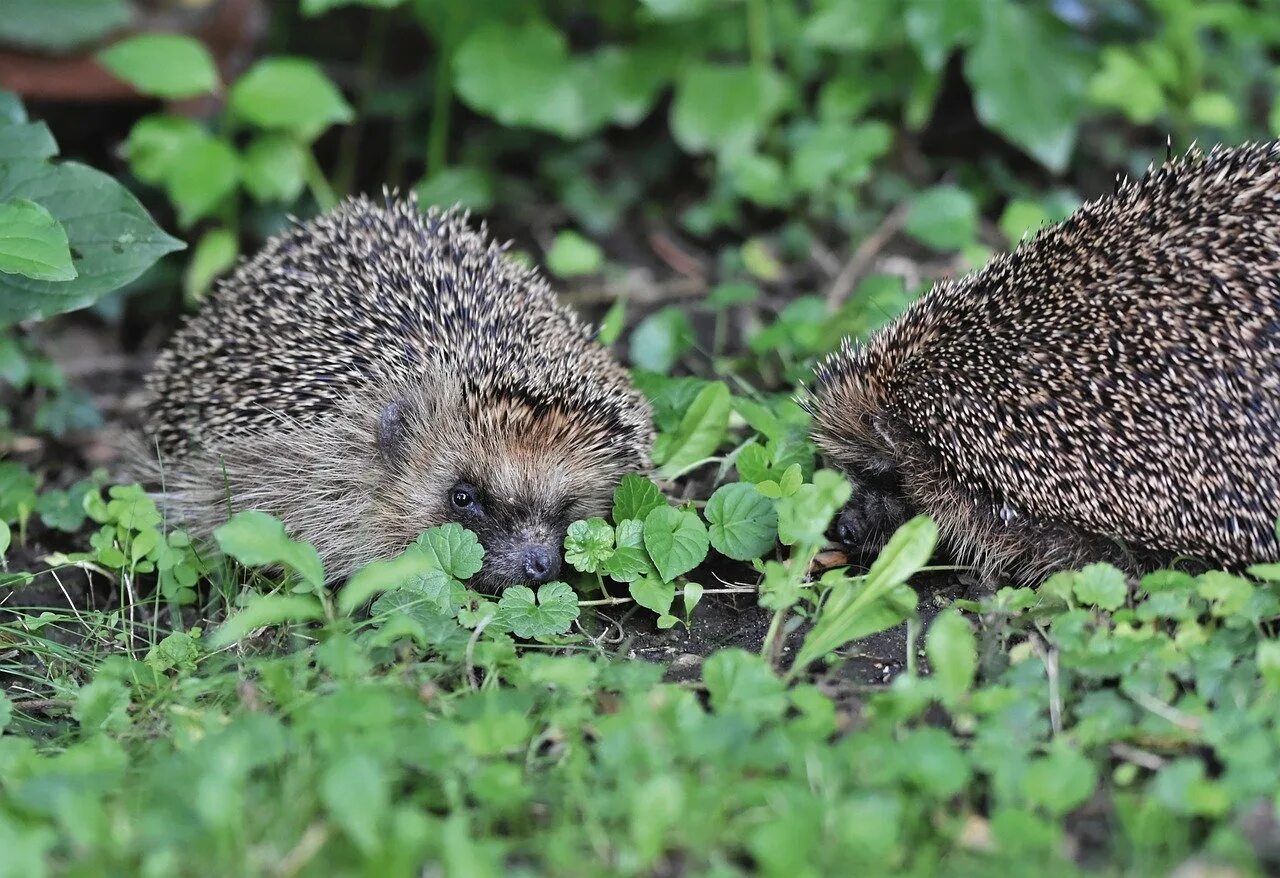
<box><xmin>0</xmin><ymin>161</ymin><xmax>183</xmax><ymax>326</ymax></box>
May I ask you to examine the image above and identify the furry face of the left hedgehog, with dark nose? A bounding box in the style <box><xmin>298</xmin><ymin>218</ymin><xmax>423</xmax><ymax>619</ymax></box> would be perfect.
<box><xmin>374</xmin><ymin>389</ymin><xmax>644</xmax><ymax>591</ymax></box>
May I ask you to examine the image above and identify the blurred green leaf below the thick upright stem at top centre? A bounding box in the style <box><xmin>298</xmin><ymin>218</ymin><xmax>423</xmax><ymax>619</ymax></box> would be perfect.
<box><xmin>671</xmin><ymin>63</ymin><xmax>786</xmax><ymax>156</ymax></box>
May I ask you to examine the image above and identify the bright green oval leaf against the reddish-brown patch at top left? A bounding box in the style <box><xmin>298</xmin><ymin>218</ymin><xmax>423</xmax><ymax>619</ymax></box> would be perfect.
<box><xmin>97</xmin><ymin>33</ymin><xmax>219</xmax><ymax>99</ymax></box>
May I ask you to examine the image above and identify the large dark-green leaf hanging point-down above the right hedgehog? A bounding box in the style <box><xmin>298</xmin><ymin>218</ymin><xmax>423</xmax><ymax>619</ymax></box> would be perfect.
<box><xmin>965</xmin><ymin>3</ymin><xmax>1089</xmax><ymax>173</ymax></box>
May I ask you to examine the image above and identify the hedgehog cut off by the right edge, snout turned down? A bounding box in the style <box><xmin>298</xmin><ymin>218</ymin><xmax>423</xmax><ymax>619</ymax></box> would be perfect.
<box><xmin>806</xmin><ymin>143</ymin><xmax>1280</xmax><ymax>585</ymax></box>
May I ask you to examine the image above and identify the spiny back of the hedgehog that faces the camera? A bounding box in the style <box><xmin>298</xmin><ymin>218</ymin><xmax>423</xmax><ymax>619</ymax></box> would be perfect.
<box><xmin>147</xmin><ymin>198</ymin><xmax>648</xmax><ymax>457</ymax></box>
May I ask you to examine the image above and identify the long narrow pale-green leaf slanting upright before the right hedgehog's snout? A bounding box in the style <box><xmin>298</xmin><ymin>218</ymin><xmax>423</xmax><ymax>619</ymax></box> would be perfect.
<box><xmin>790</xmin><ymin>516</ymin><xmax>938</xmax><ymax>676</ymax></box>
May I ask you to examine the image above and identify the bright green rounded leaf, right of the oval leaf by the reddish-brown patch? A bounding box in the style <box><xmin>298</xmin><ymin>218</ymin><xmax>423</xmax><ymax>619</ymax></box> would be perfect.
<box><xmin>229</xmin><ymin>58</ymin><xmax>355</xmax><ymax>143</ymax></box>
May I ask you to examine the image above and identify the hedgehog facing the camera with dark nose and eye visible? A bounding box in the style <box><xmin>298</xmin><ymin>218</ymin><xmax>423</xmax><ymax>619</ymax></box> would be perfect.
<box><xmin>142</xmin><ymin>196</ymin><xmax>653</xmax><ymax>591</ymax></box>
